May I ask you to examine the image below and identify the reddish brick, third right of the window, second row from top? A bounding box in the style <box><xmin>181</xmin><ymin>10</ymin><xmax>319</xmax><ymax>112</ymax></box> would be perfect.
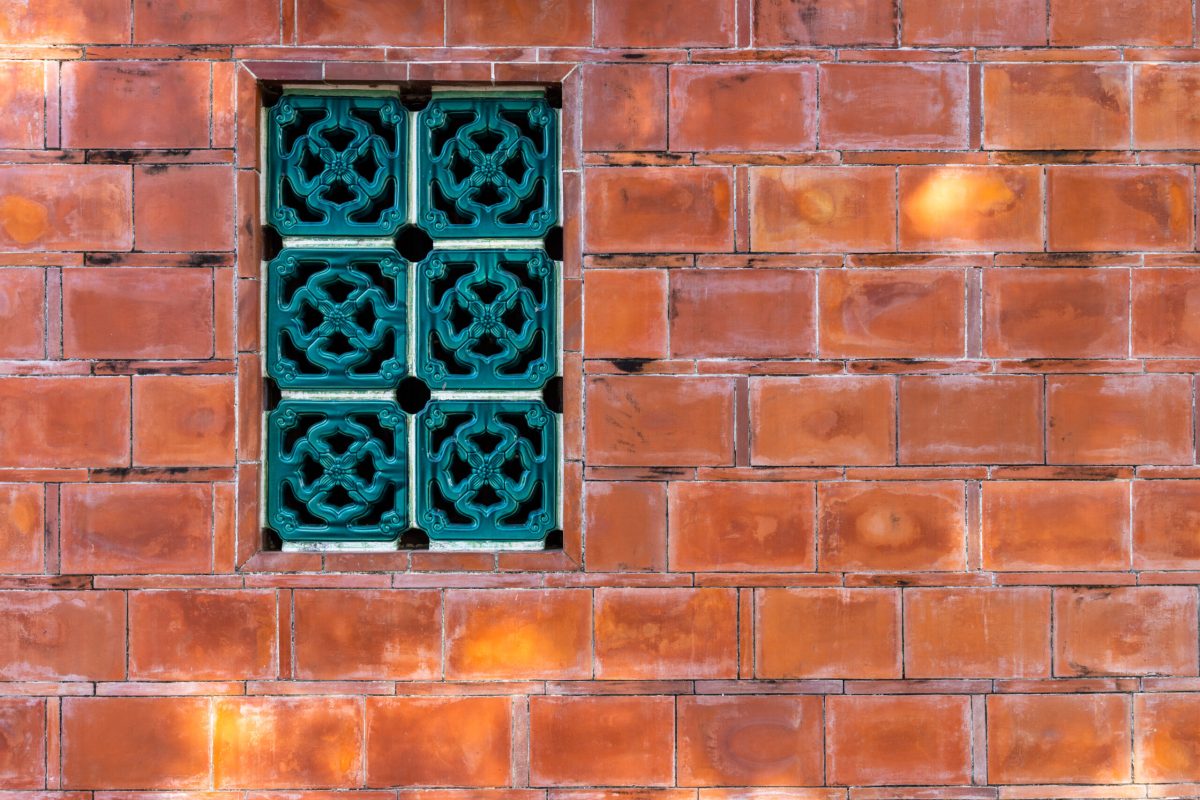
<box><xmin>818</xmin><ymin>64</ymin><xmax>967</xmax><ymax>150</ymax></box>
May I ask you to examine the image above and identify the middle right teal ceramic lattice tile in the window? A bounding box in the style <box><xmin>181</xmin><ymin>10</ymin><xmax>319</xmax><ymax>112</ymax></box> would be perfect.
<box><xmin>413</xmin><ymin>249</ymin><xmax>558</xmax><ymax>390</ymax></box>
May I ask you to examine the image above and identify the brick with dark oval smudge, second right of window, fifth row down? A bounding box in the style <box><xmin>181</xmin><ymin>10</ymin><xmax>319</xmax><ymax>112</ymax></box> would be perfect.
<box><xmin>750</xmin><ymin>375</ymin><xmax>896</xmax><ymax>467</ymax></box>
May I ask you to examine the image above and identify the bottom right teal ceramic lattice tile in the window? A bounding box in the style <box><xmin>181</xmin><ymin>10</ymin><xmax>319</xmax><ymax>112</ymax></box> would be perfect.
<box><xmin>415</xmin><ymin>401</ymin><xmax>558</xmax><ymax>542</ymax></box>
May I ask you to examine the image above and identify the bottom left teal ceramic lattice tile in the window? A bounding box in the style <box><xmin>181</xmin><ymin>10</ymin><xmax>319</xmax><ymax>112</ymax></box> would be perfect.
<box><xmin>266</xmin><ymin>399</ymin><xmax>408</xmax><ymax>542</ymax></box>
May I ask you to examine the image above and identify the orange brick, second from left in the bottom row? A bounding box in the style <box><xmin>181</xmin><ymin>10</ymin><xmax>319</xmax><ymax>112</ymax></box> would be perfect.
<box><xmin>62</xmin><ymin>697</ymin><xmax>212</xmax><ymax>789</ymax></box>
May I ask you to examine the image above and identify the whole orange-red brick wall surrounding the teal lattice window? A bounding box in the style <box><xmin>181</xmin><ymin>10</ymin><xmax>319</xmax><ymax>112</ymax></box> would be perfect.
<box><xmin>0</xmin><ymin>0</ymin><xmax>1200</xmax><ymax>800</ymax></box>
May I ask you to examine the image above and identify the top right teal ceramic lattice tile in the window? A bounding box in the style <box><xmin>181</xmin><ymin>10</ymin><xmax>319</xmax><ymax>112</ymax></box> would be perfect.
<box><xmin>416</xmin><ymin>95</ymin><xmax>558</xmax><ymax>239</ymax></box>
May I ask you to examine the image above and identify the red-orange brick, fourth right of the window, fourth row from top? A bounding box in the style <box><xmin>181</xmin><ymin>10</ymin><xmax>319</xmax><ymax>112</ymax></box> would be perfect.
<box><xmin>983</xmin><ymin>269</ymin><xmax>1129</xmax><ymax>359</ymax></box>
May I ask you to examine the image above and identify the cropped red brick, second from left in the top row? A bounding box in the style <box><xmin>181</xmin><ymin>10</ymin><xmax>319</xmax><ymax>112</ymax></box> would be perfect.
<box><xmin>133</xmin><ymin>0</ymin><xmax>280</xmax><ymax>44</ymax></box>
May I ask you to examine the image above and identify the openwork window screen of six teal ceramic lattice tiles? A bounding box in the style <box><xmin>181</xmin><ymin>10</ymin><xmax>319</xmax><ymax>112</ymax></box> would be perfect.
<box><xmin>265</xmin><ymin>91</ymin><xmax>562</xmax><ymax>548</ymax></box>
